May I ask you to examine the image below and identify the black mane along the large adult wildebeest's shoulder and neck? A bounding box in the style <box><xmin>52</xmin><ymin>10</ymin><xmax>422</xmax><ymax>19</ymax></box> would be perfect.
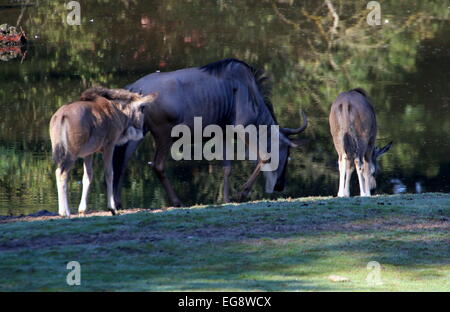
<box><xmin>200</xmin><ymin>58</ymin><xmax>278</xmax><ymax>123</ymax></box>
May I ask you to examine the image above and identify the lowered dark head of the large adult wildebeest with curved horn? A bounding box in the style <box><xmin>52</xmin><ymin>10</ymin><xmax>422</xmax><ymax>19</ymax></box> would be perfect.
<box><xmin>264</xmin><ymin>111</ymin><xmax>308</xmax><ymax>193</ymax></box>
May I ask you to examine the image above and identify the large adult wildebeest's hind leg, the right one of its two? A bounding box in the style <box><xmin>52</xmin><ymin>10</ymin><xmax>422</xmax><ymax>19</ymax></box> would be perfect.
<box><xmin>152</xmin><ymin>137</ymin><xmax>182</xmax><ymax>207</ymax></box>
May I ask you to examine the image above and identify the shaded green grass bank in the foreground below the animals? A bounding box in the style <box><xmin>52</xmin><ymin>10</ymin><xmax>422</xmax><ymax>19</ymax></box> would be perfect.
<box><xmin>0</xmin><ymin>194</ymin><xmax>450</xmax><ymax>291</ymax></box>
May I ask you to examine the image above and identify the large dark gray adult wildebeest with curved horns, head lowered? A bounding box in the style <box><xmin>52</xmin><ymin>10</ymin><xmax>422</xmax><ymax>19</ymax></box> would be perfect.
<box><xmin>114</xmin><ymin>59</ymin><xmax>307</xmax><ymax>206</ymax></box>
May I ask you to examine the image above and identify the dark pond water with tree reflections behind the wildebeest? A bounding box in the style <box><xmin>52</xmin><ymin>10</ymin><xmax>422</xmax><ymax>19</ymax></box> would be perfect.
<box><xmin>0</xmin><ymin>0</ymin><xmax>450</xmax><ymax>215</ymax></box>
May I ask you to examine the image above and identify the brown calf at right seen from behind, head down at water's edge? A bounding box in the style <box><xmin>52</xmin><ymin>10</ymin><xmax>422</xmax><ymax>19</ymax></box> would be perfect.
<box><xmin>329</xmin><ymin>88</ymin><xmax>392</xmax><ymax>197</ymax></box>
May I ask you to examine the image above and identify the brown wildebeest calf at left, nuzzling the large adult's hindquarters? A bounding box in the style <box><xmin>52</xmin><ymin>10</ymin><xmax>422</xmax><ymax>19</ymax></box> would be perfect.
<box><xmin>50</xmin><ymin>87</ymin><xmax>157</xmax><ymax>217</ymax></box>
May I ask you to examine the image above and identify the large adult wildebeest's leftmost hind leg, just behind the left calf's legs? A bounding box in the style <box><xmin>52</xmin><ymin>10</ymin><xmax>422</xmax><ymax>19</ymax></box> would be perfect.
<box><xmin>113</xmin><ymin>141</ymin><xmax>141</xmax><ymax>209</ymax></box>
